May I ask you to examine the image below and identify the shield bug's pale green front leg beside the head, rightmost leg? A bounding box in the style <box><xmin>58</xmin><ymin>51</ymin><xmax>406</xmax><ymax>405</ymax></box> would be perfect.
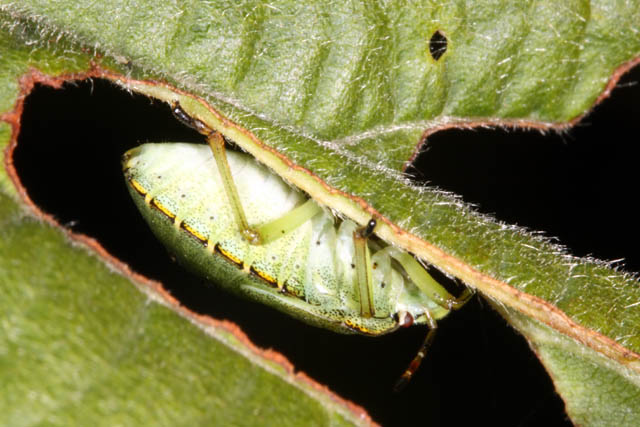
<box><xmin>389</xmin><ymin>248</ymin><xmax>475</xmax><ymax>310</ymax></box>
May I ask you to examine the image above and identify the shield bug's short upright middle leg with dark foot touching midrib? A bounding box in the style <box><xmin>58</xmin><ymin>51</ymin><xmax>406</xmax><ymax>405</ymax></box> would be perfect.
<box><xmin>353</xmin><ymin>219</ymin><xmax>376</xmax><ymax>317</ymax></box>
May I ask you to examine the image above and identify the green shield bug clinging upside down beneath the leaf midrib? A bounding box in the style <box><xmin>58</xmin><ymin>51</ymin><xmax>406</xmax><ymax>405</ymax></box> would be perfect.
<box><xmin>123</xmin><ymin>104</ymin><xmax>472</xmax><ymax>389</ymax></box>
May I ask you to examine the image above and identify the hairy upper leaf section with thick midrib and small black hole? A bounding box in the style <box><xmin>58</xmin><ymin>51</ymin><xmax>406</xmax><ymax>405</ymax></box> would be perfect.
<box><xmin>2</xmin><ymin>1</ymin><xmax>640</xmax><ymax>423</ymax></box>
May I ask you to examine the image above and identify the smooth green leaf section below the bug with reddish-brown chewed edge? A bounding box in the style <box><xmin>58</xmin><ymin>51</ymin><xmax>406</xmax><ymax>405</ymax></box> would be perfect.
<box><xmin>0</xmin><ymin>196</ymin><xmax>358</xmax><ymax>425</ymax></box>
